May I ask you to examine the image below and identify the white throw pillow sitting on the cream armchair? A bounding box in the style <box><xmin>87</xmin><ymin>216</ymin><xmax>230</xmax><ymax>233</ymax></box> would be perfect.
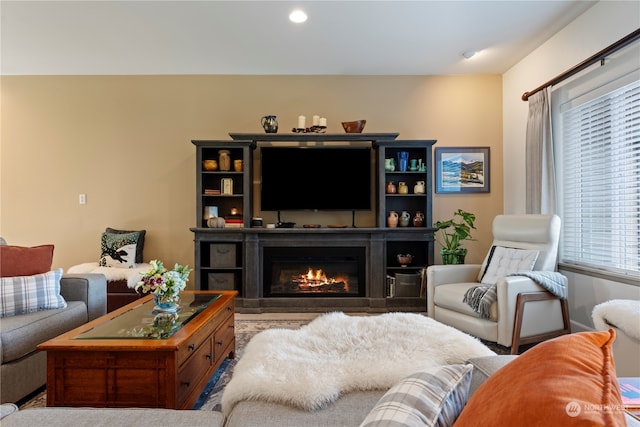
<box><xmin>480</xmin><ymin>246</ymin><xmax>539</xmax><ymax>285</ymax></box>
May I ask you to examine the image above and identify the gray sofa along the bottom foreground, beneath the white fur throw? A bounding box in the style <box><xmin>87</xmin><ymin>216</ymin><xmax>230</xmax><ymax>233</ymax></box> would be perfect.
<box><xmin>0</xmin><ymin>355</ymin><xmax>640</xmax><ymax>427</ymax></box>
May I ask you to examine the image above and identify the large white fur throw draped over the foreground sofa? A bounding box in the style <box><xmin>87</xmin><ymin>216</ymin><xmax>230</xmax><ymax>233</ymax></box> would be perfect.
<box><xmin>221</xmin><ymin>312</ymin><xmax>495</xmax><ymax>414</ymax></box>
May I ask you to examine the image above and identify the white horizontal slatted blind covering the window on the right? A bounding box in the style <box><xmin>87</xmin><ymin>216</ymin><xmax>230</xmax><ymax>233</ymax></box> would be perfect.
<box><xmin>557</xmin><ymin>80</ymin><xmax>640</xmax><ymax>277</ymax></box>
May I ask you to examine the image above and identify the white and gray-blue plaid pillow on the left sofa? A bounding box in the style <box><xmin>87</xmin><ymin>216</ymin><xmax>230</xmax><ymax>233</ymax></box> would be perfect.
<box><xmin>0</xmin><ymin>268</ymin><xmax>67</xmax><ymax>317</ymax></box>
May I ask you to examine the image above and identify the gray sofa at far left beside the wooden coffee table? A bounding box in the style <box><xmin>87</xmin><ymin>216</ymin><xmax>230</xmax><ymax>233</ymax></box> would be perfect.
<box><xmin>0</xmin><ymin>274</ymin><xmax>107</xmax><ymax>403</ymax></box>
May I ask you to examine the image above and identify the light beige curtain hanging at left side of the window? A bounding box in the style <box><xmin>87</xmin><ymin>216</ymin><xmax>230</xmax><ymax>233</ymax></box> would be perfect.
<box><xmin>525</xmin><ymin>87</ymin><xmax>556</xmax><ymax>214</ymax></box>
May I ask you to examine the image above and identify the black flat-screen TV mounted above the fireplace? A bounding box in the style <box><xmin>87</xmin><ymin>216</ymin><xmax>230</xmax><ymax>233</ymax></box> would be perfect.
<box><xmin>260</xmin><ymin>147</ymin><xmax>372</xmax><ymax>211</ymax></box>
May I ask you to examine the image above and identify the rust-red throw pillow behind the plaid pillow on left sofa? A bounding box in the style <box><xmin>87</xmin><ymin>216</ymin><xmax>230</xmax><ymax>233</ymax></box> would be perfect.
<box><xmin>0</xmin><ymin>245</ymin><xmax>53</xmax><ymax>277</ymax></box>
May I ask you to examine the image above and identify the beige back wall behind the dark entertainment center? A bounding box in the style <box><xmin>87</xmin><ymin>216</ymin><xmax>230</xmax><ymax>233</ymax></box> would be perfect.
<box><xmin>0</xmin><ymin>75</ymin><xmax>503</xmax><ymax>280</ymax></box>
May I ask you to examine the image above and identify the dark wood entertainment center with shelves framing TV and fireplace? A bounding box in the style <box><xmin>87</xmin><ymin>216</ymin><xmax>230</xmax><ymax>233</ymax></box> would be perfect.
<box><xmin>191</xmin><ymin>133</ymin><xmax>436</xmax><ymax>313</ymax></box>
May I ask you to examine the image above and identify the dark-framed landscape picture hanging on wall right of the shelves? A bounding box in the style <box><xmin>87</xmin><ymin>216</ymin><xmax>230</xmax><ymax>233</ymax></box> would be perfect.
<box><xmin>434</xmin><ymin>147</ymin><xmax>491</xmax><ymax>194</ymax></box>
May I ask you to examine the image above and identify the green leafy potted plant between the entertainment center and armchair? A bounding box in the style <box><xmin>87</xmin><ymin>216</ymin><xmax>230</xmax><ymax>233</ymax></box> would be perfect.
<box><xmin>433</xmin><ymin>209</ymin><xmax>476</xmax><ymax>264</ymax></box>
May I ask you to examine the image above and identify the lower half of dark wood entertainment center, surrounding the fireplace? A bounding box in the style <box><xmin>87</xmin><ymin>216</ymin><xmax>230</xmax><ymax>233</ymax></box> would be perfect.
<box><xmin>189</xmin><ymin>228</ymin><xmax>433</xmax><ymax>313</ymax></box>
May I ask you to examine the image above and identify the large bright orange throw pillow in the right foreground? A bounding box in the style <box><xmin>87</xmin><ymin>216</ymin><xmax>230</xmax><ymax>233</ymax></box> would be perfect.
<box><xmin>455</xmin><ymin>329</ymin><xmax>626</xmax><ymax>427</ymax></box>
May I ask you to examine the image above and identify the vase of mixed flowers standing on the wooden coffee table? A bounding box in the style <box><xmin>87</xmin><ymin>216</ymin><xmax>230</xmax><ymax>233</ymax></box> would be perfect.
<box><xmin>135</xmin><ymin>259</ymin><xmax>191</xmax><ymax>312</ymax></box>
